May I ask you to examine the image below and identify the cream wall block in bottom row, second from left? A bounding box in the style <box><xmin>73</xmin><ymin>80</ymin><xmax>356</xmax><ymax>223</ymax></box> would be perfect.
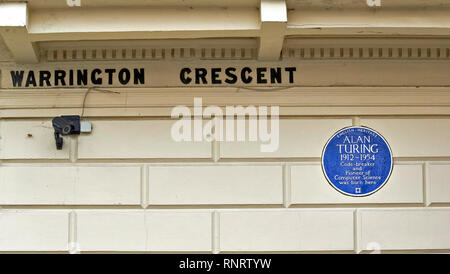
<box><xmin>77</xmin><ymin>210</ymin><xmax>212</xmax><ymax>252</ymax></box>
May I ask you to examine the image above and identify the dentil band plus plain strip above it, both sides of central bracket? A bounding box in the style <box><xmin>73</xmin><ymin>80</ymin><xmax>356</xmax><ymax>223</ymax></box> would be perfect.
<box><xmin>40</xmin><ymin>38</ymin><xmax>450</xmax><ymax>62</ymax></box>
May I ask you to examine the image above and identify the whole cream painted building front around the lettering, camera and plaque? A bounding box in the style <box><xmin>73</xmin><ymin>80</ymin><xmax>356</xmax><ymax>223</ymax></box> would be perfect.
<box><xmin>0</xmin><ymin>0</ymin><xmax>450</xmax><ymax>253</ymax></box>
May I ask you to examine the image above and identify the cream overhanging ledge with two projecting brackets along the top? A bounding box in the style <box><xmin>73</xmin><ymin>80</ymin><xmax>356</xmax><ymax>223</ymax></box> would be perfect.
<box><xmin>0</xmin><ymin>0</ymin><xmax>450</xmax><ymax>63</ymax></box>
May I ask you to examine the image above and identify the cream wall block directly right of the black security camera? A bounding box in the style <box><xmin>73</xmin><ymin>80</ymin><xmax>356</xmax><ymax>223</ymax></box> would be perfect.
<box><xmin>78</xmin><ymin>120</ymin><xmax>211</xmax><ymax>159</ymax></box>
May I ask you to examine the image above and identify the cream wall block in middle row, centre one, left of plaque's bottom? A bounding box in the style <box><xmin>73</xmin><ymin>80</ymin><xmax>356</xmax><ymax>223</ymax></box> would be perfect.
<box><xmin>149</xmin><ymin>164</ymin><xmax>283</xmax><ymax>205</ymax></box>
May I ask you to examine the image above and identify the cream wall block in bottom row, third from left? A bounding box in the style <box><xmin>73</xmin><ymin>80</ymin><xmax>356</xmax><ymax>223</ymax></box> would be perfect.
<box><xmin>220</xmin><ymin>210</ymin><xmax>354</xmax><ymax>251</ymax></box>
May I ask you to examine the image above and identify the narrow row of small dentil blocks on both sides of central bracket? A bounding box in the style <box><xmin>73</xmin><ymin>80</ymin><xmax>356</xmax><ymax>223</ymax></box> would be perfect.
<box><xmin>41</xmin><ymin>47</ymin><xmax>450</xmax><ymax>62</ymax></box>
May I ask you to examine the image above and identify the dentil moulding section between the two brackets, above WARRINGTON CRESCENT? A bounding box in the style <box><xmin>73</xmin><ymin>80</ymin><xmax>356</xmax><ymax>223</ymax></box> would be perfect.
<box><xmin>40</xmin><ymin>38</ymin><xmax>258</xmax><ymax>62</ymax></box>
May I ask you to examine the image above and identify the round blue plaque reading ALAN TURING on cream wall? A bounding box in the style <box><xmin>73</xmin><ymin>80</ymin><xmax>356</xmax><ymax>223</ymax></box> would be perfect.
<box><xmin>322</xmin><ymin>127</ymin><xmax>394</xmax><ymax>197</ymax></box>
